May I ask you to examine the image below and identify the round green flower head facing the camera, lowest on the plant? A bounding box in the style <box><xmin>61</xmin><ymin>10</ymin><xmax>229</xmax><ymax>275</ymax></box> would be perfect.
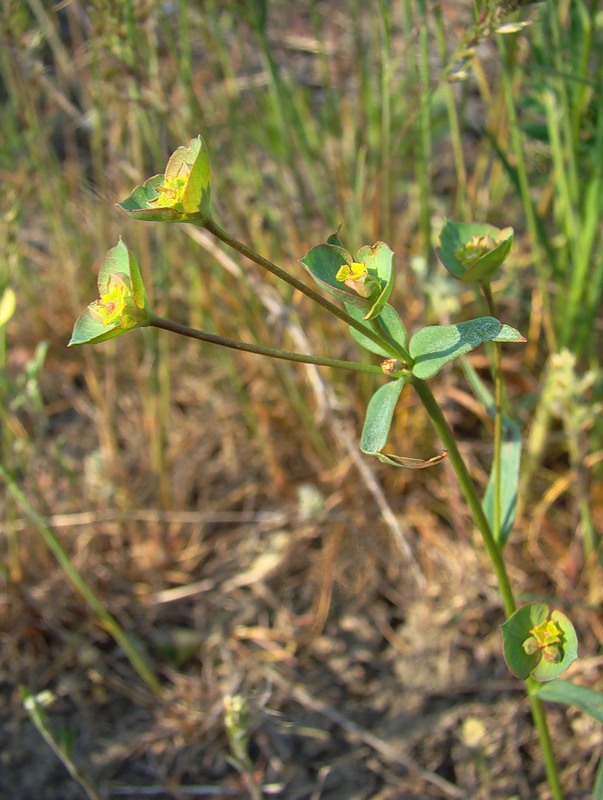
<box><xmin>502</xmin><ymin>603</ymin><xmax>578</xmax><ymax>681</ymax></box>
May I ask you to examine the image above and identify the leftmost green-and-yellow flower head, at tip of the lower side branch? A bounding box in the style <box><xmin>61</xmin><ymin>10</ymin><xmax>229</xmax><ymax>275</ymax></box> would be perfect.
<box><xmin>69</xmin><ymin>237</ymin><xmax>153</xmax><ymax>345</ymax></box>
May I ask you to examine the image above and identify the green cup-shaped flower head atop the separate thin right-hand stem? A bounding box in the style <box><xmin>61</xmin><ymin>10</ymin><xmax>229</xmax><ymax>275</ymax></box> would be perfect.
<box><xmin>436</xmin><ymin>220</ymin><xmax>514</xmax><ymax>283</ymax></box>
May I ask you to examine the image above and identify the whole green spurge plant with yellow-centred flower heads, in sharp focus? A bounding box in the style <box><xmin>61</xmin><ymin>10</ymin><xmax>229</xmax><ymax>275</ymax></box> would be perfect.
<box><xmin>70</xmin><ymin>136</ymin><xmax>603</xmax><ymax>800</ymax></box>
